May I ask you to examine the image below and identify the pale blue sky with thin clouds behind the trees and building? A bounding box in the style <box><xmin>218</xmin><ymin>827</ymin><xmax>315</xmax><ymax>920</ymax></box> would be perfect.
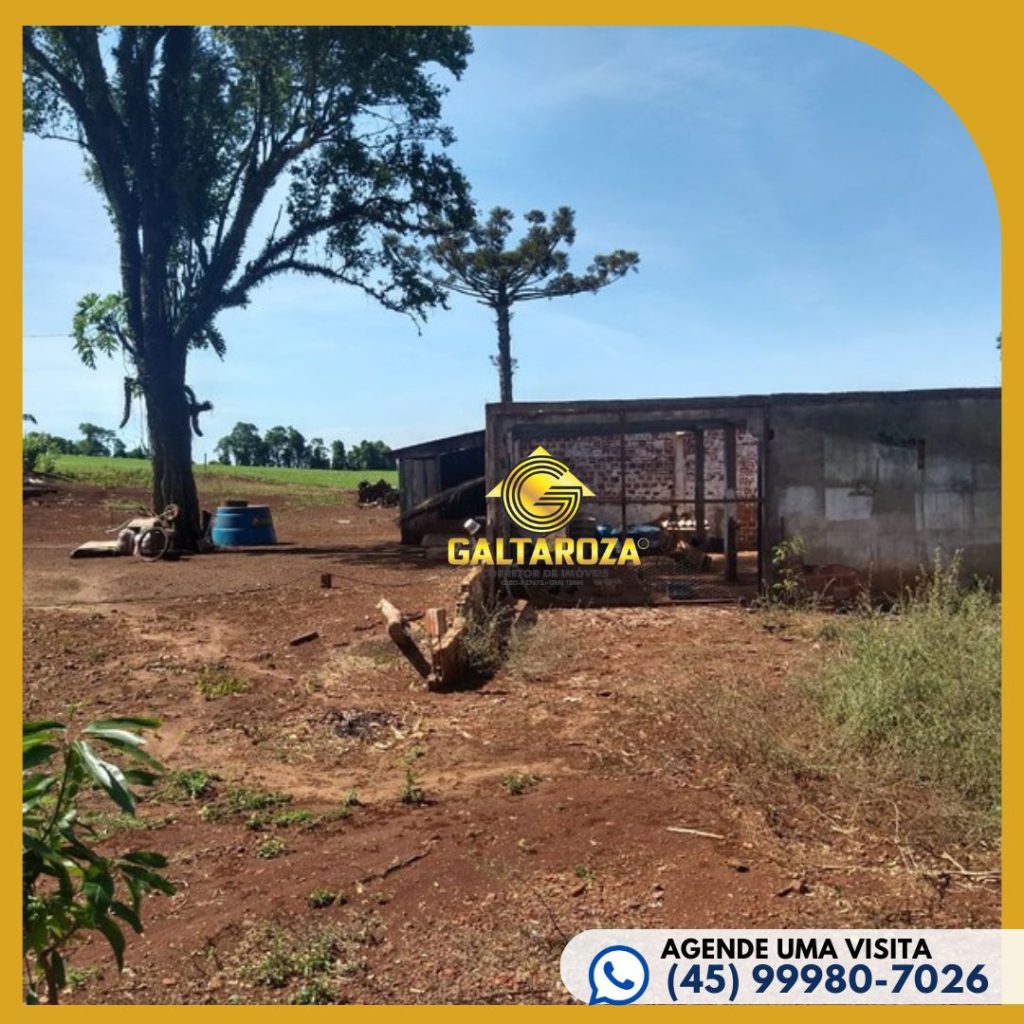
<box><xmin>24</xmin><ymin>28</ymin><xmax>1000</xmax><ymax>459</ymax></box>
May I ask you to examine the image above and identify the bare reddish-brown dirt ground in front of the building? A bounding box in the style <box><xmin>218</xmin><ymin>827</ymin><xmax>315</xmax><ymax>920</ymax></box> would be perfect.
<box><xmin>25</xmin><ymin>486</ymin><xmax>999</xmax><ymax>1004</ymax></box>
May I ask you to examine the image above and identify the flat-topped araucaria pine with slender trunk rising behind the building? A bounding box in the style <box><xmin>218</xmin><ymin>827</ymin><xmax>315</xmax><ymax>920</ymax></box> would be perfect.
<box><xmin>430</xmin><ymin>206</ymin><xmax>640</xmax><ymax>401</ymax></box>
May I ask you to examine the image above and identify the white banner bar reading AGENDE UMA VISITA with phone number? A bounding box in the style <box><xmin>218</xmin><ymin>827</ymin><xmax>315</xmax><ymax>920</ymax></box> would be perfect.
<box><xmin>561</xmin><ymin>929</ymin><xmax>1024</xmax><ymax>1006</ymax></box>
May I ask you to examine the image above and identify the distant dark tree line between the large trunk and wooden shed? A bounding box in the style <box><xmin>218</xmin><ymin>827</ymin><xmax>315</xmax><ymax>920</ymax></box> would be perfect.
<box><xmin>214</xmin><ymin>423</ymin><xmax>395</xmax><ymax>469</ymax></box>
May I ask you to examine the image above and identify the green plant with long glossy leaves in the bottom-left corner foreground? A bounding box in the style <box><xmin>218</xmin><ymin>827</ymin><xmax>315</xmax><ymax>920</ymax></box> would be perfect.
<box><xmin>22</xmin><ymin>718</ymin><xmax>174</xmax><ymax>1004</ymax></box>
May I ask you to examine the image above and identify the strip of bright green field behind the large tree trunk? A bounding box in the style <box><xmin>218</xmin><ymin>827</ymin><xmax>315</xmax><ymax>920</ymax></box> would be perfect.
<box><xmin>54</xmin><ymin>455</ymin><xmax>398</xmax><ymax>493</ymax></box>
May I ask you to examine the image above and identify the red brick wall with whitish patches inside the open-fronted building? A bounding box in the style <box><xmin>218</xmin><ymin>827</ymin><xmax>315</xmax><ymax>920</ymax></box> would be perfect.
<box><xmin>521</xmin><ymin>430</ymin><xmax>758</xmax><ymax>549</ymax></box>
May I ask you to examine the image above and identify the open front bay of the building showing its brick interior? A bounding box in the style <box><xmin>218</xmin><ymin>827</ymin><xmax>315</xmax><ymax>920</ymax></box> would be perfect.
<box><xmin>516</xmin><ymin>420</ymin><xmax>762</xmax><ymax>604</ymax></box>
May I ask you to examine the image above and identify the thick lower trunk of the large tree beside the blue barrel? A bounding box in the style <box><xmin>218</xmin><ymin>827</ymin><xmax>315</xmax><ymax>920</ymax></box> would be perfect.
<box><xmin>139</xmin><ymin>340</ymin><xmax>201</xmax><ymax>551</ymax></box>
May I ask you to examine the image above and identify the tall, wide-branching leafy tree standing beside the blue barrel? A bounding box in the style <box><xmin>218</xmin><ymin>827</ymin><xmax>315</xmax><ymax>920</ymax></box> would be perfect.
<box><xmin>24</xmin><ymin>26</ymin><xmax>472</xmax><ymax>545</ymax></box>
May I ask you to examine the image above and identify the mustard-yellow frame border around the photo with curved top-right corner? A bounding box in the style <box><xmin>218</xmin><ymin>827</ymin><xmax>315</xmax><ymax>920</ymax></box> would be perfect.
<box><xmin>6</xmin><ymin>0</ymin><xmax>1024</xmax><ymax>1021</ymax></box>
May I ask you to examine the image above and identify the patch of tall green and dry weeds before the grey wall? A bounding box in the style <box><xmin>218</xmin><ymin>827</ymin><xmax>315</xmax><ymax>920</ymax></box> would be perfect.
<box><xmin>693</xmin><ymin>557</ymin><xmax>1000</xmax><ymax>847</ymax></box>
